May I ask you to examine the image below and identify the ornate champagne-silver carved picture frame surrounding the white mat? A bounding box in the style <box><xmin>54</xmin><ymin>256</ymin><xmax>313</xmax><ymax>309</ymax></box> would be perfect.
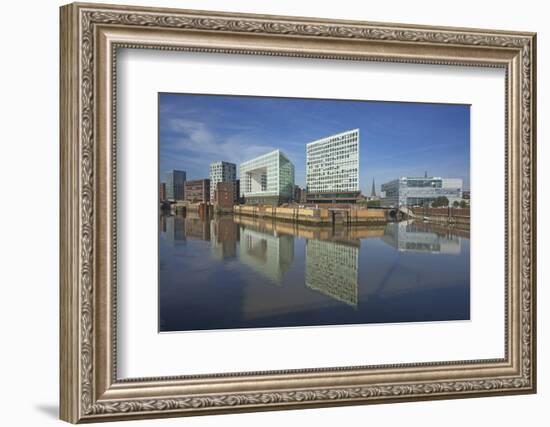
<box><xmin>60</xmin><ymin>4</ymin><xmax>536</xmax><ymax>423</ymax></box>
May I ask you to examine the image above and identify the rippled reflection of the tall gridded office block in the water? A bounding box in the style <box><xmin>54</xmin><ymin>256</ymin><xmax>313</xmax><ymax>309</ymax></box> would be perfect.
<box><xmin>306</xmin><ymin>239</ymin><xmax>359</xmax><ymax>306</ymax></box>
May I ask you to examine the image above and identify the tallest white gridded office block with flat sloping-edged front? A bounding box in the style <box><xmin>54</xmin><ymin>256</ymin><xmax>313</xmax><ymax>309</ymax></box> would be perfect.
<box><xmin>306</xmin><ymin>129</ymin><xmax>360</xmax><ymax>203</ymax></box>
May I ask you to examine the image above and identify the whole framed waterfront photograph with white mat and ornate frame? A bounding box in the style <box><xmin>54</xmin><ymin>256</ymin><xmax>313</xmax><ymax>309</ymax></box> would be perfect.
<box><xmin>60</xmin><ymin>4</ymin><xmax>536</xmax><ymax>423</ymax></box>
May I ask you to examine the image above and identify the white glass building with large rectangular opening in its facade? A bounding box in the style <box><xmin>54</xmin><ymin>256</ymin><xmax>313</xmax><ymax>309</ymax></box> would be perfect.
<box><xmin>239</xmin><ymin>150</ymin><xmax>294</xmax><ymax>205</ymax></box>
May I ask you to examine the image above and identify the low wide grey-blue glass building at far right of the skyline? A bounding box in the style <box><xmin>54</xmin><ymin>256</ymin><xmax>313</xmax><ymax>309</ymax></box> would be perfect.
<box><xmin>382</xmin><ymin>176</ymin><xmax>462</xmax><ymax>207</ymax></box>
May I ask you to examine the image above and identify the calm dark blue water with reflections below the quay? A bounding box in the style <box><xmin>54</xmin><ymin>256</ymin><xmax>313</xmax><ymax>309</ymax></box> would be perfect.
<box><xmin>159</xmin><ymin>215</ymin><xmax>470</xmax><ymax>332</ymax></box>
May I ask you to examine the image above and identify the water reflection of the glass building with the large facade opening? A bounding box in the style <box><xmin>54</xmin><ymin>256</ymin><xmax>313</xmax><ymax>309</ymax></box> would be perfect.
<box><xmin>239</xmin><ymin>227</ymin><xmax>294</xmax><ymax>283</ymax></box>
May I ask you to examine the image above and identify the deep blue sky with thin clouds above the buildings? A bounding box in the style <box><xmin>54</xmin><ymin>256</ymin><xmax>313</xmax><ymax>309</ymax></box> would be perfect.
<box><xmin>159</xmin><ymin>93</ymin><xmax>470</xmax><ymax>194</ymax></box>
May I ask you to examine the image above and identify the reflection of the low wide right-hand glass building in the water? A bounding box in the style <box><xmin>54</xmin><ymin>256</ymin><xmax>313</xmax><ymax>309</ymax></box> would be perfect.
<box><xmin>382</xmin><ymin>222</ymin><xmax>462</xmax><ymax>255</ymax></box>
